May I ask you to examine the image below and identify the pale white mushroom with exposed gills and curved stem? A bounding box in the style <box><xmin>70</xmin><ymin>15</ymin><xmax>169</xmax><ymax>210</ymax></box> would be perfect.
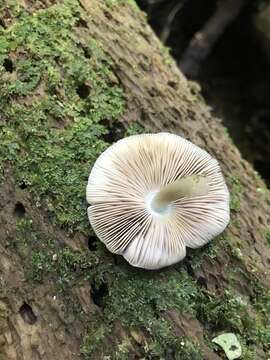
<box><xmin>86</xmin><ymin>132</ymin><xmax>230</xmax><ymax>269</ymax></box>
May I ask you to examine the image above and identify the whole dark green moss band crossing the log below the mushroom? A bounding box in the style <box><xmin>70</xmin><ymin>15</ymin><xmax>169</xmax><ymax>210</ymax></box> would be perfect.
<box><xmin>19</xmin><ymin>221</ymin><xmax>270</xmax><ymax>359</ymax></box>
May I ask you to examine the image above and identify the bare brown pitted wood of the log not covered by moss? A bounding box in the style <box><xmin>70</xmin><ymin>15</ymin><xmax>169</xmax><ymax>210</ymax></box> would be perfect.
<box><xmin>0</xmin><ymin>0</ymin><xmax>270</xmax><ymax>360</ymax></box>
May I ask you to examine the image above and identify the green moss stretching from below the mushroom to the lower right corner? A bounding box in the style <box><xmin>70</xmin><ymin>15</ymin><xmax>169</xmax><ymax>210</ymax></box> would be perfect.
<box><xmin>80</xmin><ymin>256</ymin><xmax>269</xmax><ymax>359</ymax></box>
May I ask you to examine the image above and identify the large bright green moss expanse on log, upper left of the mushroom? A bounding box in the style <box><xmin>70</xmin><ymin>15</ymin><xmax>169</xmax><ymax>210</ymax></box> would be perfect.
<box><xmin>0</xmin><ymin>0</ymin><xmax>124</xmax><ymax>232</ymax></box>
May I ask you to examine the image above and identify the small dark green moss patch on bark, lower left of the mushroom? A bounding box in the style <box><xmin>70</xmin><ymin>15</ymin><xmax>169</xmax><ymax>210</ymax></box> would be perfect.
<box><xmin>12</xmin><ymin>216</ymin><xmax>98</xmax><ymax>292</ymax></box>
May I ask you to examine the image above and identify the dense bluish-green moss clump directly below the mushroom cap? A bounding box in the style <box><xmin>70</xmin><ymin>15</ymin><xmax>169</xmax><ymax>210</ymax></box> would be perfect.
<box><xmin>105</xmin><ymin>268</ymin><xmax>198</xmax><ymax>331</ymax></box>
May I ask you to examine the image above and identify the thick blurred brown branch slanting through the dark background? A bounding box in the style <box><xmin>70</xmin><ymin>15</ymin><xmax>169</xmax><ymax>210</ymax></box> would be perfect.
<box><xmin>179</xmin><ymin>0</ymin><xmax>245</xmax><ymax>76</ymax></box>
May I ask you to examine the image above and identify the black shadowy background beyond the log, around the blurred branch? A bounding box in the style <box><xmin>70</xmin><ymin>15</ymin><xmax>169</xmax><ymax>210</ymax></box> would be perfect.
<box><xmin>137</xmin><ymin>0</ymin><xmax>270</xmax><ymax>186</ymax></box>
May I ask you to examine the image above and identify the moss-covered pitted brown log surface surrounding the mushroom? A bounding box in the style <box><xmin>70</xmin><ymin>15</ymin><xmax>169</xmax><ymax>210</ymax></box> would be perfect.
<box><xmin>0</xmin><ymin>0</ymin><xmax>270</xmax><ymax>360</ymax></box>
